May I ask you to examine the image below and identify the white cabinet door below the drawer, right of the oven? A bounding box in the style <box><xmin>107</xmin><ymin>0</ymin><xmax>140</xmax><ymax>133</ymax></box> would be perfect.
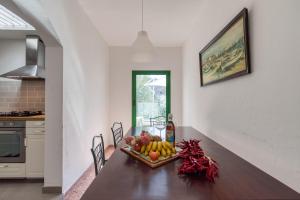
<box><xmin>26</xmin><ymin>135</ymin><xmax>44</xmax><ymax>178</ymax></box>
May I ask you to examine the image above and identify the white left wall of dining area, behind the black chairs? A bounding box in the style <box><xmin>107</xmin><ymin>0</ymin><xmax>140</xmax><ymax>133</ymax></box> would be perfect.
<box><xmin>42</xmin><ymin>0</ymin><xmax>111</xmax><ymax>192</ymax></box>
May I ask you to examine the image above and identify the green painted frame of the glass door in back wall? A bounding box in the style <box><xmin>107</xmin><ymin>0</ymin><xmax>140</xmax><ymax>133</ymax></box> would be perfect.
<box><xmin>131</xmin><ymin>70</ymin><xmax>171</xmax><ymax>127</ymax></box>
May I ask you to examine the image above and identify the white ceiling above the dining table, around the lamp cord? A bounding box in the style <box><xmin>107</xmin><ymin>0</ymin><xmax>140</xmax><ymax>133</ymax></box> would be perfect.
<box><xmin>78</xmin><ymin>0</ymin><xmax>201</xmax><ymax>46</ymax></box>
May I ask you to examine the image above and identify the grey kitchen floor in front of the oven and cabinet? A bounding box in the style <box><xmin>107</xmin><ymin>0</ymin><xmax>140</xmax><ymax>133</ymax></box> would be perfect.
<box><xmin>0</xmin><ymin>182</ymin><xmax>62</xmax><ymax>200</ymax></box>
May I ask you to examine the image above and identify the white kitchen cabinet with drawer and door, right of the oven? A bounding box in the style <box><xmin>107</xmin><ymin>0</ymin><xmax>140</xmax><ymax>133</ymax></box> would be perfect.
<box><xmin>26</xmin><ymin>121</ymin><xmax>45</xmax><ymax>178</ymax></box>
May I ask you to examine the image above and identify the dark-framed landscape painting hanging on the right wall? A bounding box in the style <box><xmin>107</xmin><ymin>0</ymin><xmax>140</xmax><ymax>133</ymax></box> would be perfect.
<box><xmin>199</xmin><ymin>8</ymin><xmax>250</xmax><ymax>86</ymax></box>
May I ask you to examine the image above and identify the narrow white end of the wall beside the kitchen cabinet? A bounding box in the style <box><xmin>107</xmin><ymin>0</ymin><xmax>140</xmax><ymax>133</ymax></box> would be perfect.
<box><xmin>44</xmin><ymin>47</ymin><xmax>63</xmax><ymax>187</ymax></box>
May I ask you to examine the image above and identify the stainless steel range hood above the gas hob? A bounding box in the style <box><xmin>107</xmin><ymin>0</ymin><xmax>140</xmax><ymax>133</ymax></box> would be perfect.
<box><xmin>0</xmin><ymin>35</ymin><xmax>45</xmax><ymax>80</ymax></box>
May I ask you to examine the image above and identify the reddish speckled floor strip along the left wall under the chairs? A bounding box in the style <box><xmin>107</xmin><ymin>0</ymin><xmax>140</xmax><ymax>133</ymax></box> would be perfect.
<box><xmin>64</xmin><ymin>146</ymin><xmax>115</xmax><ymax>200</ymax></box>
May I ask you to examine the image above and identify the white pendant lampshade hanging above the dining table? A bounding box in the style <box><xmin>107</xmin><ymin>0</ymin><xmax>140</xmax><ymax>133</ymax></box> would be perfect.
<box><xmin>132</xmin><ymin>31</ymin><xmax>154</xmax><ymax>63</ymax></box>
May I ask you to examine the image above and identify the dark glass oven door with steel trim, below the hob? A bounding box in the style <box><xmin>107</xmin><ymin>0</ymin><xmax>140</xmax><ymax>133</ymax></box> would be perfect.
<box><xmin>0</xmin><ymin>128</ymin><xmax>25</xmax><ymax>163</ymax></box>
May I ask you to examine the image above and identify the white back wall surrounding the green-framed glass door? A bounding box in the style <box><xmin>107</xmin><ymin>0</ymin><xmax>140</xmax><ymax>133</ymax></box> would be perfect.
<box><xmin>109</xmin><ymin>47</ymin><xmax>182</xmax><ymax>142</ymax></box>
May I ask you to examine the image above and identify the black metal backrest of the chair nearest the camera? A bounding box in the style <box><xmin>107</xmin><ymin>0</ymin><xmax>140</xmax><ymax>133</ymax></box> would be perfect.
<box><xmin>91</xmin><ymin>134</ymin><xmax>105</xmax><ymax>176</ymax></box>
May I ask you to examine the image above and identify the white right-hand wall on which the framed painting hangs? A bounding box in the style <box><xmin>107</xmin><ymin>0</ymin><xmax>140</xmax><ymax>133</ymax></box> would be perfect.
<box><xmin>183</xmin><ymin>0</ymin><xmax>300</xmax><ymax>192</ymax></box>
